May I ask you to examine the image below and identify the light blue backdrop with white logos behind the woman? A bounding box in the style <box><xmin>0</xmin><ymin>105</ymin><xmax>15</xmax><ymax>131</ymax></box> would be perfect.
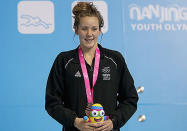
<box><xmin>0</xmin><ymin>0</ymin><xmax>187</xmax><ymax>131</ymax></box>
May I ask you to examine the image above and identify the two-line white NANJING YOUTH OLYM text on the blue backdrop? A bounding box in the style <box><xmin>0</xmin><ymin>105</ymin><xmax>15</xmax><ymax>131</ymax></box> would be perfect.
<box><xmin>129</xmin><ymin>4</ymin><xmax>187</xmax><ymax>31</ymax></box>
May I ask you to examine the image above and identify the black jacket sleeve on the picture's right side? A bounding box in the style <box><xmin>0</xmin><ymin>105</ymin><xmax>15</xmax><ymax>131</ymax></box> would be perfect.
<box><xmin>110</xmin><ymin>55</ymin><xmax>138</xmax><ymax>129</ymax></box>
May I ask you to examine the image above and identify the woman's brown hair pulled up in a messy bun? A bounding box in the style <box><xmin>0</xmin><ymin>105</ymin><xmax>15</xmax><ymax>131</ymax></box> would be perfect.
<box><xmin>72</xmin><ymin>2</ymin><xmax>104</xmax><ymax>30</ymax></box>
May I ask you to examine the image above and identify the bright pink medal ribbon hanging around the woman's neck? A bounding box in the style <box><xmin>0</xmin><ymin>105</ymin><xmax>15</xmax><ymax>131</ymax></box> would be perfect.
<box><xmin>78</xmin><ymin>46</ymin><xmax>100</xmax><ymax>104</ymax></box>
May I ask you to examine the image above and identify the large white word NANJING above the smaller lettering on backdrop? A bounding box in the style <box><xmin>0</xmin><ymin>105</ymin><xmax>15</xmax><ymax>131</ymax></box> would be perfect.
<box><xmin>129</xmin><ymin>4</ymin><xmax>187</xmax><ymax>23</ymax></box>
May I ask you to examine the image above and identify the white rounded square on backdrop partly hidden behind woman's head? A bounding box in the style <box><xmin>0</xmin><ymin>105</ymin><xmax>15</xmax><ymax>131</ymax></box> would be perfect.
<box><xmin>72</xmin><ymin>1</ymin><xmax>108</xmax><ymax>33</ymax></box>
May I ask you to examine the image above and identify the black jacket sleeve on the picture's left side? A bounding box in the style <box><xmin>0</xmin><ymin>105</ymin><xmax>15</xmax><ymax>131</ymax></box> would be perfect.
<box><xmin>45</xmin><ymin>56</ymin><xmax>77</xmax><ymax>126</ymax></box>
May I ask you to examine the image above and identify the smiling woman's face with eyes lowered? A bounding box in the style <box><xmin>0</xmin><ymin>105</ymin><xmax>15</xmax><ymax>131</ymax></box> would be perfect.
<box><xmin>76</xmin><ymin>16</ymin><xmax>101</xmax><ymax>49</ymax></box>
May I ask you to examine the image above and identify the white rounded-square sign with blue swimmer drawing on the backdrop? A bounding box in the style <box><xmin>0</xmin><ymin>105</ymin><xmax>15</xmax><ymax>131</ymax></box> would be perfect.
<box><xmin>17</xmin><ymin>1</ymin><xmax>54</xmax><ymax>34</ymax></box>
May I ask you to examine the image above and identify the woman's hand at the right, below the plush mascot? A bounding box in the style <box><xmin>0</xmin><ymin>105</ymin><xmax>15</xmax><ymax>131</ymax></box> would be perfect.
<box><xmin>94</xmin><ymin>119</ymin><xmax>113</xmax><ymax>131</ymax></box>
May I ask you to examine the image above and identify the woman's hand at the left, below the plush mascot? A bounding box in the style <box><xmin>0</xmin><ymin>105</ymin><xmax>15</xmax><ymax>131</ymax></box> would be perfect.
<box><xmin>74</xmin><ymin>118</ymin><xmax>96</xmax><ymax>131</ymax></box>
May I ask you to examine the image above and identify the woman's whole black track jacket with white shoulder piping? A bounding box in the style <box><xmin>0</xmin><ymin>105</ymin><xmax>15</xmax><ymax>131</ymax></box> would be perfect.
<box><xmin>45</xmin><ymin>45</ymin><xmax>138</xmax><ymax>131</ymax></box>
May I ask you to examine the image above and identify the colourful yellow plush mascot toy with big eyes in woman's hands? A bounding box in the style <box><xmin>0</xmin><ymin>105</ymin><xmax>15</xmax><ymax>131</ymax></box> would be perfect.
<box><xmin>83</xmin><ymin>103</ymin><xmax>109</xmax><ymax>123</ymax></box>
